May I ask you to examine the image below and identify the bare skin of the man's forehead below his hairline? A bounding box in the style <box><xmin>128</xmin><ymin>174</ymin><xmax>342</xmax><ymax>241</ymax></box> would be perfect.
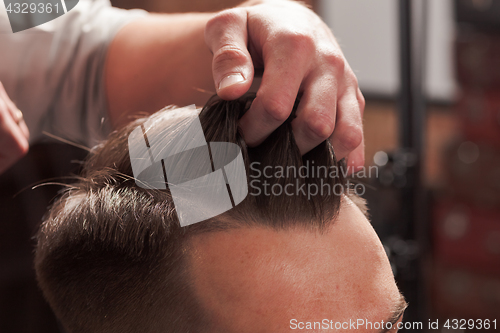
<box><xmin>189</xmin><ymin>198</ymin><xmax>402</xmax><ymax>333</ymax></box>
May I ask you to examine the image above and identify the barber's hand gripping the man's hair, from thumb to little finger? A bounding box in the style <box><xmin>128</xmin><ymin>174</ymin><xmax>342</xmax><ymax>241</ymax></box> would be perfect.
<box><xmin>205</xmin><ymin>0</ymin><xmax>364</xmax><ymax>170</ymax></box>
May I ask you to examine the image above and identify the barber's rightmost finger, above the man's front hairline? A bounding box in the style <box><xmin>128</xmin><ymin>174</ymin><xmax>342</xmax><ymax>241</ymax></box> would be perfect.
<box><xmin>330</xmin><ymin>89</ymin><xmax>365</xmax><ymax>172</ymax></box>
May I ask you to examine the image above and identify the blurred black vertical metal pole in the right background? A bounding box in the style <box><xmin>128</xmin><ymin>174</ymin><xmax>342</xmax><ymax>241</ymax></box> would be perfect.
<box><xmin>396</xmin><ymin>0</ymin><xmax>427</xmax><ymax>326</ymax></box>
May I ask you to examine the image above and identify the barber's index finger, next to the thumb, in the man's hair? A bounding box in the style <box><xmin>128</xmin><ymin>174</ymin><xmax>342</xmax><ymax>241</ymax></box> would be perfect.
<box><xmin>240</xmin><ymin>35</ymin><xmax>314</xmax><ymax>146</ymax></box>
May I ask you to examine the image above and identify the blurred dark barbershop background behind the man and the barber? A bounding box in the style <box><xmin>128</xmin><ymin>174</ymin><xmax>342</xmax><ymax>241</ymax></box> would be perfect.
<box><xmin>0</xmin><ymin>0</ymin><xmax>500</xmax><ymax>333</ymax></box>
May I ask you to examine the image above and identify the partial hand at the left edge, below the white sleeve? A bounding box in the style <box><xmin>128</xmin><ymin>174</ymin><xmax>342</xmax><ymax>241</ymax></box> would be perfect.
<box><xmin>0</xmin><ymin>82</ymin><xmax>29</xmax><ymax>174</ymax></box>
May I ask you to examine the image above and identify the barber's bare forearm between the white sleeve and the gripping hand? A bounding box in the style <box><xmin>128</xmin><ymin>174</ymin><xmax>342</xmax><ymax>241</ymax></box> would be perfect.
<box><xmin>106</xmin><ymin>13</ymin><xmax>215</xmax><ymax>127</ymax></box>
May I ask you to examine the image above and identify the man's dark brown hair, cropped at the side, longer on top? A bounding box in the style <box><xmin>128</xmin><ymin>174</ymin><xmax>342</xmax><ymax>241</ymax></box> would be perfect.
<box><xmin>35</xmin><ymin>96</ymin><xmax>356</xmax><ymax>333</ymax></box>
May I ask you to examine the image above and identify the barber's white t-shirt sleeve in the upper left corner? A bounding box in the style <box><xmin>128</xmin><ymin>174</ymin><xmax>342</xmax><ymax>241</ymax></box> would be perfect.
<box><xmin>0</xmin><ymin>0</ymin><xmax>147</xmax><ymax>147</ymax></box>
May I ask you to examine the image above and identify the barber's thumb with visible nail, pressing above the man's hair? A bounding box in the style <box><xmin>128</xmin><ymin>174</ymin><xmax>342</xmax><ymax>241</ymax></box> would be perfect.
<box><xmin>205</xmin><ymin>8</ymin><xmax>254</xmax><ymax>100</ymax></box>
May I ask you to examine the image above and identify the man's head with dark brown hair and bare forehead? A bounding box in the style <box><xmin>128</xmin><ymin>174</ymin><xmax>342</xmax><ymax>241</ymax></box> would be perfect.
<box><xmin>35</xmin><ymin>97</ymin><xmax>404</xmax><ymax>333</ymax></box>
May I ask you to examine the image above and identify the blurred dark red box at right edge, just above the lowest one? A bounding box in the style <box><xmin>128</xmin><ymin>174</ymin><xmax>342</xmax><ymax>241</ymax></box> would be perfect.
<box><xmin>433</xmin><ymin>199</ymin><xmax>500</xmax><ymax>277</ymax></box>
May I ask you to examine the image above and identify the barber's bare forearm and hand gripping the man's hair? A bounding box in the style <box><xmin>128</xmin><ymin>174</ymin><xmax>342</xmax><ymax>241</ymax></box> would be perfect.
<box><xmin>106</xmin><ymin>1</ymin><xmax>364</xmax><ymax>168</ymax></box>
